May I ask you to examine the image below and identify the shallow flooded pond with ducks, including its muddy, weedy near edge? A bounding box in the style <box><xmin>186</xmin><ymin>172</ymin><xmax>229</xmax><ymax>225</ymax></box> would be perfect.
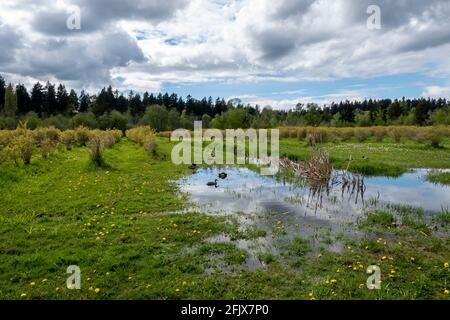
<box><xmin>177</xmin><ymin>167</ymin><xmax>450</xmax><ymax>268</ymax></box>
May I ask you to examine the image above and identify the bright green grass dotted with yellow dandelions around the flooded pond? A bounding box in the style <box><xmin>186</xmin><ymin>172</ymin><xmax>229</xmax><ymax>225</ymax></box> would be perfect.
<box><xmin>0</xmin><ymin>138</ymin><xmax>450</xmax><ymax>299</ymax></box>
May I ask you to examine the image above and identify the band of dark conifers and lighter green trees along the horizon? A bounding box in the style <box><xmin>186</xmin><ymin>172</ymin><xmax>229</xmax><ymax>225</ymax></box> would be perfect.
<box><xmin>0</xmin><ymin>76</ymin><xmax>450</xmax><ymax>131</ymax></box>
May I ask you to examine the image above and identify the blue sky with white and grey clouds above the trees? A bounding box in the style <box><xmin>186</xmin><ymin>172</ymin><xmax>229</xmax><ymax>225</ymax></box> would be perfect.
<box><xmin>0</xmin><ymin>0</ymin><xmax>450</xmax><ymax>108</ymax></box>
